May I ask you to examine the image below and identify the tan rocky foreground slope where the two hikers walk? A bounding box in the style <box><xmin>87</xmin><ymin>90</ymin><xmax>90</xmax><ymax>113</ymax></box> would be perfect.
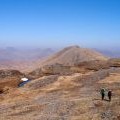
<box><xmin>0</xmin><ymin>67</ymin><xmax>120</xmax><ymax>120</ymax></box>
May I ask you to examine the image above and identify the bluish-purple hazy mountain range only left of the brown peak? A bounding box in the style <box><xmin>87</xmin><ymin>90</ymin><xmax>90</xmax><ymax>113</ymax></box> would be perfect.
<box><xmin>0</xmin><ymin>47</ymin><xmax>55</xmax><ymax>62</ymax></box>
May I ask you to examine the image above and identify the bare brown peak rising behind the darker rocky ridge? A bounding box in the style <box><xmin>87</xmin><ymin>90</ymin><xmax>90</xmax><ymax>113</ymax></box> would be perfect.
<box><xmin>37</xmin><ymin>46</ymin><xmax>108</xmax><ymax>66</ymax></box>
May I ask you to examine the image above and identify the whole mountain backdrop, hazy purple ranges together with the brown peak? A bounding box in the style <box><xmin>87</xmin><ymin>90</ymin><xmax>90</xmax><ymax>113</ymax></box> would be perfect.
<box><xmin>0</xmin><ymin>46</ymin><xmax>120</xmax><ymax>72</ymax></box>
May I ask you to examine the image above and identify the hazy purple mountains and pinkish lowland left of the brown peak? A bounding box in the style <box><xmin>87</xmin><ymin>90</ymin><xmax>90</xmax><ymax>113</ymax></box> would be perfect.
<box><xmin>0</xmin><ymin>47</ymin><xmax>56</xmax><ymax>71</ymax></box>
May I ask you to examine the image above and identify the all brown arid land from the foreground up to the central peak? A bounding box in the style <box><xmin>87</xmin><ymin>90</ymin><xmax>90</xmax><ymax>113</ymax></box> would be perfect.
<box><xmin>0</xmin><ymin>46</ymin><xmax>120</xmax><ymax>120</ymax></box>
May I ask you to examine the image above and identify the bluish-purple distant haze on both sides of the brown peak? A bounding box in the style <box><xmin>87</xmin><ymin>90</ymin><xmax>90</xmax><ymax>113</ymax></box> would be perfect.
<box><xmin>0</xmin><ymin>46</ymin><xmax>120</xmax><ymax>62</ymax></box>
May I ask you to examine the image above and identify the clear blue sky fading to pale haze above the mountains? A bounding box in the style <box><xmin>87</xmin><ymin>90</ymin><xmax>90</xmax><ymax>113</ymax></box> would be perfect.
<box><xmin>0</xmin><ymin>0</ymin><xmax>120</xmax><ymax>48</ymax></box>
